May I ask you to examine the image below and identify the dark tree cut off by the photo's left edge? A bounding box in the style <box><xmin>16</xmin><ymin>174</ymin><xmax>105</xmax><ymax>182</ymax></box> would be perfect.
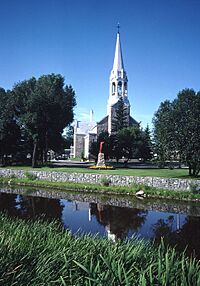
<box><xmin>0</xmin><ymin>88</ymin><xmax>20</xmax><ymax>165</ymax></box>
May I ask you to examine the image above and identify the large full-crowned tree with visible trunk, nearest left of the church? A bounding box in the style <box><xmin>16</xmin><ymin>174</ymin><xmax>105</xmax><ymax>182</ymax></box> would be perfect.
<box><xmin>12</xmin><ymin>74</ymin><xmax>76</xmax><ymax>167</ymax></box>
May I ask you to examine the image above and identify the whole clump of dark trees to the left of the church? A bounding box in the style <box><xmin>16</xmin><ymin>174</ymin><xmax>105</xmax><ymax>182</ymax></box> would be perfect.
<box><xmin>0</xmin><ymin>74</ymin><xmax>76</xmax><ymax>167</ymax></box>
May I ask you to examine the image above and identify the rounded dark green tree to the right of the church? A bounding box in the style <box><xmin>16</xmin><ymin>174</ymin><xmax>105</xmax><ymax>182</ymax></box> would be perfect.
<box><xmin>153</xmin><ymin>89</ymin><xmax>200</xmax><ymax>176</ymax></box>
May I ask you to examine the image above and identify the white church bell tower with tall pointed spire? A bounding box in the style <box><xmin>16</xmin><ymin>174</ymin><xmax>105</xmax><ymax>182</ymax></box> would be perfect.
<box><xmin>107</xmin><ymin>25</ymin><xmax>130</xmax><ymax>134</ymax></box>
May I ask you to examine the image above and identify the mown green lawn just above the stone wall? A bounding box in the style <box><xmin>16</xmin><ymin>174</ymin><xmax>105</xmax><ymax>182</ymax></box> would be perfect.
<box><xmin>8</xmin><ymin>166</ymin><xmax>195</xmax><ymax>179</ymax></box>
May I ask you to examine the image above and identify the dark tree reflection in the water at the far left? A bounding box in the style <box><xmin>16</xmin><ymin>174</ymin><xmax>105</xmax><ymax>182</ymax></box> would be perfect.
<box><xmin>0</xmin><ymin>193</ymin><xmax>63</xmax><ymax>225</ymax></box>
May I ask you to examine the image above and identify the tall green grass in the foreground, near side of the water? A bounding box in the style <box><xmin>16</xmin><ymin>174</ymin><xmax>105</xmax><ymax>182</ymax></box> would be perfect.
<box><xmin>0</xmin><ymin>215</ymin><xmax>200</xmax><ymax>286</ymax></box>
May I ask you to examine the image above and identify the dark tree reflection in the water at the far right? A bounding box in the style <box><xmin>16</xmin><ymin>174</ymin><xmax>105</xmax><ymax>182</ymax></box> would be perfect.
<box><xmin>153</xmin><ymin>216</ymin><xmax>200</xmax><ymax>258</ymax></box>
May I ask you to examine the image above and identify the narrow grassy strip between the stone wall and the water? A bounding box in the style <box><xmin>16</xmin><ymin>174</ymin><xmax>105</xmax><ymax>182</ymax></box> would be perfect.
<box><xmin>0</xmin><ymin>177</ymin><xmax>200</xmax><ymax>201</ymax></box>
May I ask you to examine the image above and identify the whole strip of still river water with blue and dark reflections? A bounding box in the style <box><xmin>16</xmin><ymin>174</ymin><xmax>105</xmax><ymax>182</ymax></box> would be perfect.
<box><xmin>0</xmin><ymin>190</ymin><xmax>200</xmax><ymax>258</ymax></box>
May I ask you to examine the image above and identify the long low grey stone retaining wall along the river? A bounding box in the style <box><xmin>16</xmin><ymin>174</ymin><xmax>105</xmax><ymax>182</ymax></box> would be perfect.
<box><xmin>0</xmin><ymin>169</ymin><xmax>200</xmax><ymax>191</ymax></box>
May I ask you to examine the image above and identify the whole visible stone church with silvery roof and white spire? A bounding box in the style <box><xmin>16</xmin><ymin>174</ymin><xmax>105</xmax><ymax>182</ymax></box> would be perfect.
<box><xmin>71</xmin><ymin>31</ymin><xmax>139</xmax><ymax>158</ymax></box>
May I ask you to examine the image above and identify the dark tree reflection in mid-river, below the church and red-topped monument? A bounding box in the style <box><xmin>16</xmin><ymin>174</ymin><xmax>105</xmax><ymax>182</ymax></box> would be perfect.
<box><xmin>90</xmin><ymin>204</ymin><xmax>148</xmax><ymax>239</ymax></box>
